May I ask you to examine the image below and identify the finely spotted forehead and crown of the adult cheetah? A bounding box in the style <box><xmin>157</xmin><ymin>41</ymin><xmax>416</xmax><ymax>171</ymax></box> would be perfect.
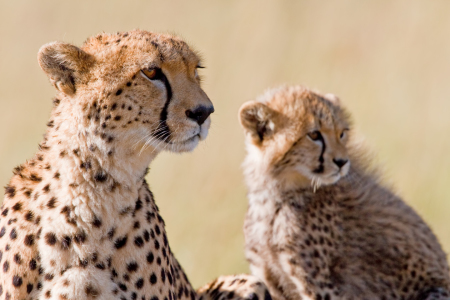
<box><xmin>81</xmin><ymin>30</ymin><xmax>201</xmax><ymax>65</ymax></box>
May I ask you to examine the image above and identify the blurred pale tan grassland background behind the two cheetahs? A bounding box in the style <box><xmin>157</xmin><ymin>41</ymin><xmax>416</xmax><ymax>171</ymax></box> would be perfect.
<box><xmin>0</xmin><ymin>0</ymin><xmax>450</xmax><ymax>287</ymax></box>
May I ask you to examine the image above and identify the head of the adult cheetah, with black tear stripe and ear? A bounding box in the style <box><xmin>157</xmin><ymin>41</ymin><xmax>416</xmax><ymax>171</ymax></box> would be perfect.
<box><xmin>38</xmin><ymin>30</ymin><xmax>214</xmax><ymax>152</ymax></box>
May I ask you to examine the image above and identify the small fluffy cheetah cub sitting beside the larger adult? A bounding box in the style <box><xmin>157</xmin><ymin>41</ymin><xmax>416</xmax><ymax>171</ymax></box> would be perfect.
<box><xmin>239</xmin><ymin>86</ymin><xmax>450</xmax><ymax>300</ymax></box>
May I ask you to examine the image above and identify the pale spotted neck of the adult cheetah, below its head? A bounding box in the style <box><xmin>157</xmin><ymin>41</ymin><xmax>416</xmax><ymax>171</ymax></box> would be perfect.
<box><xmin>10</xmin><ymin>95</ymin><xmax>162</xmax><ymax>219</ymax></box>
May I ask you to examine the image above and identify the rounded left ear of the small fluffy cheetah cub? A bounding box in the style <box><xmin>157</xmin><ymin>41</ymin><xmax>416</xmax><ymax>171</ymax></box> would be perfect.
<box><xmin>239</xmin><ymin>101</ymin><xmax>277</xmax><ymax>144</ymax></box>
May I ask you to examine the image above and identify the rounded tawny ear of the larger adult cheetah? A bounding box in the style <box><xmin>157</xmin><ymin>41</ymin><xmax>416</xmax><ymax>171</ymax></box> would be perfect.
<box><xmin>38</xmin><ymin>42</ymin><xmax>94</xmax><ymax>95</ymax></box>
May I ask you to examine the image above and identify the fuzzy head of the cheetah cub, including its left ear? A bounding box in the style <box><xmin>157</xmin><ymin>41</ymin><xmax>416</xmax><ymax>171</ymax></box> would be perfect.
<box><xmin>239</xmin><ymin>86</ymin><xmax>350</xmax><ymax>188</ymax></box>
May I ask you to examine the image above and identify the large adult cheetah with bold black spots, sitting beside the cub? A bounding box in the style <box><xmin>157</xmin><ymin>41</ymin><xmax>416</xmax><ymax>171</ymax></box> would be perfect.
<box><xmin>0</xmin><ymin>30</ymin><xmax>265</xmax><ymax>300</ymax></box>
